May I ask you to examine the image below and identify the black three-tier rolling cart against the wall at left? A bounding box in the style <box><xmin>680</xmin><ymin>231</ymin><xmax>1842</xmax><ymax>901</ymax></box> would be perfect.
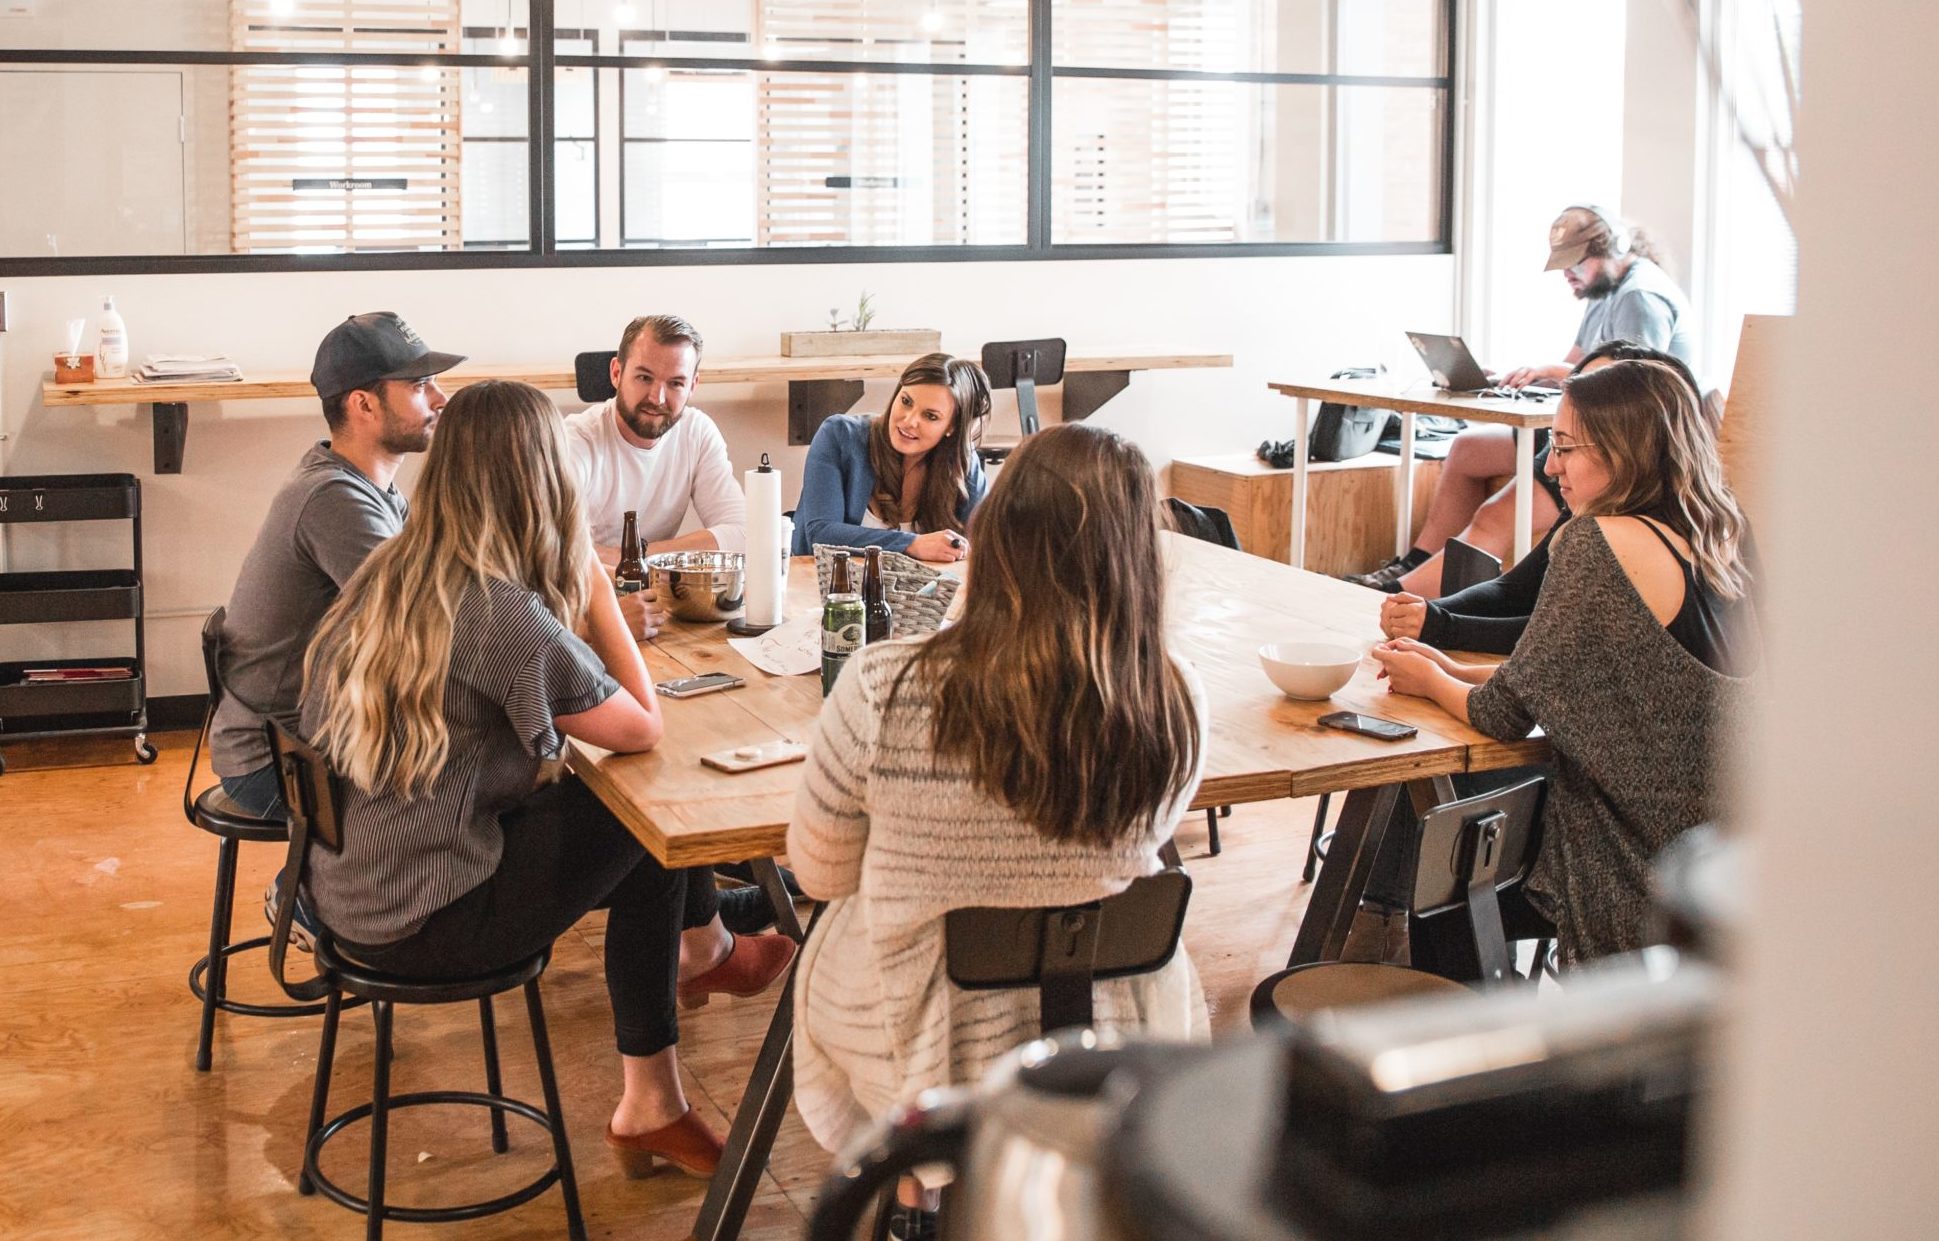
<box><xmin>0</xmin><ymin>473</ymin><xmax>155</xmax><ymax>774</ymax></box>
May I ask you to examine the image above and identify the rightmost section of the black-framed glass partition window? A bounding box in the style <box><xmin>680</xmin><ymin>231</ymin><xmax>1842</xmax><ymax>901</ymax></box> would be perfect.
<box><xmin>1051</xmin><ymin>0</ymin><xmax>1448</xmax><ymax>246</ymax></box>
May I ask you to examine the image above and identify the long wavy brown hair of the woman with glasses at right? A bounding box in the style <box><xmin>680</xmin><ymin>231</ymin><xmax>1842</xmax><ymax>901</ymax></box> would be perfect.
<box><xmin>1563</xmin><ymin>359</ymin><xmax>1749</xmax><ymax>599</ymax></box>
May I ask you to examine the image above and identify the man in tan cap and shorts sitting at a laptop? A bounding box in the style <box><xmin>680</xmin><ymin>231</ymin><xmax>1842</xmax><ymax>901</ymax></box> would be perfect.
<box><xmin>1348</xmin><ymin>204</ymin><xmax>1697</xmax><ymax>599</ymax></box>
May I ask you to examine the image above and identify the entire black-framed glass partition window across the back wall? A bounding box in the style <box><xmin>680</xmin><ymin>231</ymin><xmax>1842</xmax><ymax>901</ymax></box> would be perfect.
<box><xmin>0</xmin><ymin>0</ymin><xmax>1452</xmax><ymax>273</ymax></box>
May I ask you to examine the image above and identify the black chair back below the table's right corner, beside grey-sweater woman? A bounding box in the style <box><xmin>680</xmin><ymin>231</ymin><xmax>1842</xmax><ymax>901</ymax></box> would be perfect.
<box><xmin>1414</xmin><ymin>776</ymin><xmax>1547</xmax><ymax>983</ymax></box>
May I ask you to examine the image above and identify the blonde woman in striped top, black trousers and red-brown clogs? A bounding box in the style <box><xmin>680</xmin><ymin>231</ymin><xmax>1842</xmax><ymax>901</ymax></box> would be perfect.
<box><xmin>302</xmin><ymin>382</ymin><xmax>793</xmax><ymax>1177</ymax></box>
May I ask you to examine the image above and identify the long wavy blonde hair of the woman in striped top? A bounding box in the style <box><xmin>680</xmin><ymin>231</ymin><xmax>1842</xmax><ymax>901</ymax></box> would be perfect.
<box><xmin>302</xmin><ymin>380</ymin><xmax>593</xmax><ymax>797</ymax></box>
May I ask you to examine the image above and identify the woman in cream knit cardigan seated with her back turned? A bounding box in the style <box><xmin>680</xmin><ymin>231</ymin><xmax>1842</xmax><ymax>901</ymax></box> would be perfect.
<box><xmin>787</xmin><ymin>423</ymin><xmax>1208</xmax><ymax>1150</ymax></box>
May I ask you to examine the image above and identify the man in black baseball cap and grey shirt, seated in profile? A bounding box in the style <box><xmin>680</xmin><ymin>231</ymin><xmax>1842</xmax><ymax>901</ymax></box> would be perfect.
<box><xmin>209</xmin><ymin>310</ymin><xmax>465</xmax><ymax>938</ymax></box>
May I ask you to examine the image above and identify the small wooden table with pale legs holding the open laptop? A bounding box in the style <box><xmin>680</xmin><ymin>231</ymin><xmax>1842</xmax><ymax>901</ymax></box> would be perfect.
<box><xmin>1266</xmin><ymin>376</ymin><xmax>1555</xmax><ymax>568</ymax></box>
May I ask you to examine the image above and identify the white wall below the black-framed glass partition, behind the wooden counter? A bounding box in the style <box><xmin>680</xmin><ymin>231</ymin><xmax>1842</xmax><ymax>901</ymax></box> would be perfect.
<box><xmin>0</xmin><ymin>258</ymin><xmax>1454</xmax><ymax>694</ymax></box>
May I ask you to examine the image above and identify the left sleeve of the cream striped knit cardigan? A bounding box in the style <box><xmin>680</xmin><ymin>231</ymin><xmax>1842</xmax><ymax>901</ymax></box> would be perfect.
<box><xmin>787</xmin><ymin>650</ymin><xmax>880</xmax><ymax>900</ymax></box>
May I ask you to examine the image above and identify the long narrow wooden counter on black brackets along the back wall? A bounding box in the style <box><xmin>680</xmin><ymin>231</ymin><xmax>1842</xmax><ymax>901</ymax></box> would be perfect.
<box><xmin>41</xmin><ymin>349</ymin><xmax>1231</xmax><ymax>473</ymax></box>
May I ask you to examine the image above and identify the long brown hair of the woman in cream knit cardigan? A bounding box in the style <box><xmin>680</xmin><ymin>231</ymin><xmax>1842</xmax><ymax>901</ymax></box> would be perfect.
<box><xmin>906</xmin><ymin>423</ymin><xmax>1198</xmax><ymax>845</ymax></box>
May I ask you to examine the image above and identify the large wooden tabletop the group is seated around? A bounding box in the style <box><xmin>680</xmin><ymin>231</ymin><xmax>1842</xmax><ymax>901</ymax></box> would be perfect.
<box><xmin>572</xmin><ymin>533</ymin><xmax>1547</xmax><ymax>867</ymax></box>
